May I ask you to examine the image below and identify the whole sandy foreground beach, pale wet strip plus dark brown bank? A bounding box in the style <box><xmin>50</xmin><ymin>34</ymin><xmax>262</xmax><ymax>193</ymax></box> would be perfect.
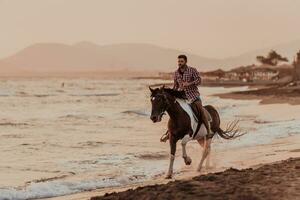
<box><xmin>51</xmin><ymin>135</ymin><xmax>300</xmax><ymax>200</ymax></box>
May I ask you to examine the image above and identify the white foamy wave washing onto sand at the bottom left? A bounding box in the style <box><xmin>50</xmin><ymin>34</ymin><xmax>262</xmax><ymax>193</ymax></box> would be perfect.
<box><xmin>0</xmin><ymin>165</ymin><xmax>162</xmax><ymax>200</ymax></box>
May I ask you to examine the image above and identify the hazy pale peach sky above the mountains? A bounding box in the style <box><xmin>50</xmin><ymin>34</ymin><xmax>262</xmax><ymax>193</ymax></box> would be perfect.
<box><xmin>0</xmin><ymin>0</ymin><xmax>300</xmax><ymax>58</ymax></box>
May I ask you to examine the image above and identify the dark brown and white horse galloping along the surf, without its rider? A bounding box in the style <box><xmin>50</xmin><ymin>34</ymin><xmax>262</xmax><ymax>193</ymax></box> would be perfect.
<box><xmin>149</xmin><ymin>87</ymin><xmax>243</xmax><ymax>178</ymax></box>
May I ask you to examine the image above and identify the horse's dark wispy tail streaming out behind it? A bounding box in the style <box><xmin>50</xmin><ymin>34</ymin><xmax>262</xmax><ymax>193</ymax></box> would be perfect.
<box><xmin>216</xmin><ymin>120</ymin><xmax>246</xmax><ymax>140</ymax></box>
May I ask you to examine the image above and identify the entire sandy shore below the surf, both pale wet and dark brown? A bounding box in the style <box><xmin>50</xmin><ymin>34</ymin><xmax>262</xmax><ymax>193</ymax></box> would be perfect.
<box><xmin>49</xmin><ymin>135</ymin><xmax>300</xmax><ymax>200</ymax></box>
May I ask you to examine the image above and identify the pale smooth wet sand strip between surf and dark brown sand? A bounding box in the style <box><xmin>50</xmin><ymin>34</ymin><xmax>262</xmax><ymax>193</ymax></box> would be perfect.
<box><xmin>47</xmin><ymin>135</ymin><xmax>300</xmax><ymax>200</ymax></box>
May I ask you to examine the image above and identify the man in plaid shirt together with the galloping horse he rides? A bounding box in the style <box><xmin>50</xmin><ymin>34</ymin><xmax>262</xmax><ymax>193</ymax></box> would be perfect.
<box><xmin>149</xmin><ymin>55</ymin><xmax>245</xmax><ymax>178</ymax></box>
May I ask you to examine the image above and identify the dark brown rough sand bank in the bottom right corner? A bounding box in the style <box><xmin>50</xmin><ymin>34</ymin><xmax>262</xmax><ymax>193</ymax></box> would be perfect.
<box><xmin>91</xmin><ymin>157</ymin><xmax>300</xmax><ymax>200</ymax></box>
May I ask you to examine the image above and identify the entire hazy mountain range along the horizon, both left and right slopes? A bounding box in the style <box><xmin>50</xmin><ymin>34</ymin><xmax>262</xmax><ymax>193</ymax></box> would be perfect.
<box><xmin>0</xmin><ymin>40</ymin><xmax>300</xmax><ymax>74</ymax></box>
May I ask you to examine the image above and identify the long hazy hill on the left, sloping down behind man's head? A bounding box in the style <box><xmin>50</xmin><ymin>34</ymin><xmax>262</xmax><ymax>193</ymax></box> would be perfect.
<box><xmin>2</xmin><ymin>42</ymin><xmax>217</xmax><ymax>72</ymax></box>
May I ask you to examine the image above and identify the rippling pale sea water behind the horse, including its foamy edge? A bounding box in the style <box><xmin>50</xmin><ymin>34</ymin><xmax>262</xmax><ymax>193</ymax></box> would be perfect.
<box><xmin>0</xmin><ymin>78</ymin><xmax>300</xmax><ymax>199</ymax></box>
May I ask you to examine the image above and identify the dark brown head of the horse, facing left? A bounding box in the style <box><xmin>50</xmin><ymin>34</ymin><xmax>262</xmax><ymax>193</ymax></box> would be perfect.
<box><xmin>149</xmin><ymin>86</ymin><xmax>169</xmax><ymax>123</ymax></box>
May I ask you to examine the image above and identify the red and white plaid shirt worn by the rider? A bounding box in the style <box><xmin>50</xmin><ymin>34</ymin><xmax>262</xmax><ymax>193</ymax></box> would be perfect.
<box><xmin>174</xmin><ymin>66</ymin><xmax>201</xmax><ymax>102</ymax></box>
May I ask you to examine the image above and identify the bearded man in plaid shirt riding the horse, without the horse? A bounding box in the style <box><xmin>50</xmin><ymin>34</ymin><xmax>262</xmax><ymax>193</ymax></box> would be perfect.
<box><xmin>161</xmin><ymin>55</ymin><xmax>210</xmax><ymax>142</ymax></box>
